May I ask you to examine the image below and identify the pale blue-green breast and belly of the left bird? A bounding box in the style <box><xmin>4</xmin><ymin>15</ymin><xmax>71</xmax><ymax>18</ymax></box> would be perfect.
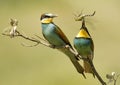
<box><xmin>42</xmin><ymin>23</ymin><xmax>66</xmax><ymax>46</ymax></box>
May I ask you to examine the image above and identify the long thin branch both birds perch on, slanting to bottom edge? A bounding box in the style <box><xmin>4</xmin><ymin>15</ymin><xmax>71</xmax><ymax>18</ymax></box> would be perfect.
<box><xmin>2</xmin><ymin>30</ymin><xmax>106</xmax><ymax>85</ymax></box>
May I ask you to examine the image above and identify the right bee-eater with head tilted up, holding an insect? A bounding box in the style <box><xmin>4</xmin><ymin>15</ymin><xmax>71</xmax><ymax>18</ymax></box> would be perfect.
<box><xmin>74</xmin><ymin>19</ymin><xmax>94</xmax><ymax>76</ymax></box>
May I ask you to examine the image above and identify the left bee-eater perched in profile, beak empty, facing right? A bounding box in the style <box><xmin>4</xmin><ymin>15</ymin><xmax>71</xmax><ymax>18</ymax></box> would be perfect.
<box><xmin>40</xmin><ymin>13</ymin><xmax>86</xmax><ymax>78</ymax></box>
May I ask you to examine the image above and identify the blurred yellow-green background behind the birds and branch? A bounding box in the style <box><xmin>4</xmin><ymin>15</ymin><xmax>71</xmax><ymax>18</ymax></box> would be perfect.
<box><xmin>0</xmin><ymin>0</ymin><xmax>120</xmax><ymax>85</ymax></box>
